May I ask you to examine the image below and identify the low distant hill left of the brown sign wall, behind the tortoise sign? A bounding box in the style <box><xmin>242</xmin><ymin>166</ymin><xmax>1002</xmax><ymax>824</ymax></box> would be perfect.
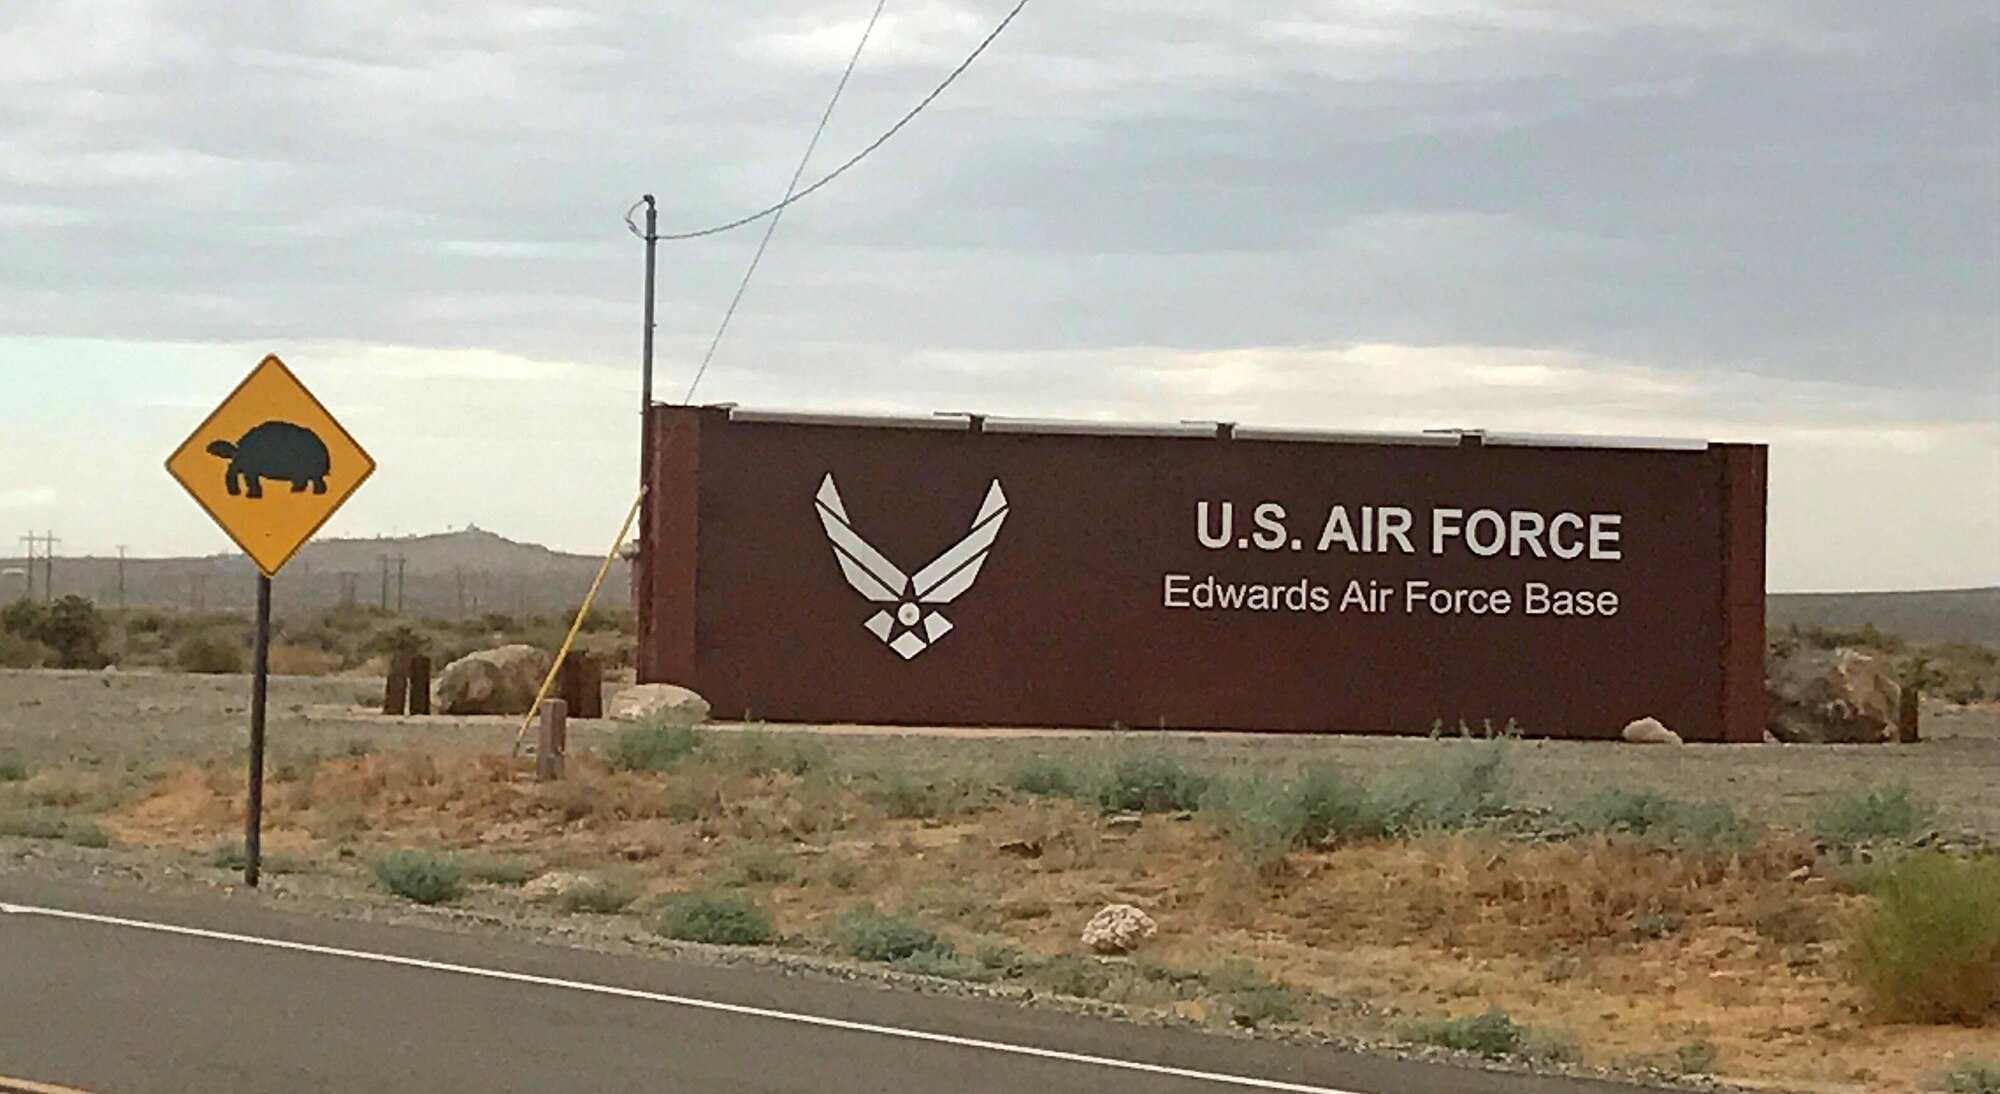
<box><xmin>0</xmin><ymin>528</ymin><xmax>632</xmax><ymax>618</ymax></box>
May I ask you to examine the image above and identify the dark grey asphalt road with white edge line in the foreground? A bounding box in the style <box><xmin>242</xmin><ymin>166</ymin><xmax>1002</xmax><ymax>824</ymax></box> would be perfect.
<box><xmin>0</xmin><ymin>876</ymin><xmax>1656</xmax><ymax>1094</ymax></box>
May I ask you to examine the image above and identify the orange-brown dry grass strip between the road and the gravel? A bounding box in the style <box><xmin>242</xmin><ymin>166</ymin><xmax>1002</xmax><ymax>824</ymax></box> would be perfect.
<box><xmin>54</xmin><ymin>742</ymin><xmax>1992</xmax><ymax>1090</ymax></box>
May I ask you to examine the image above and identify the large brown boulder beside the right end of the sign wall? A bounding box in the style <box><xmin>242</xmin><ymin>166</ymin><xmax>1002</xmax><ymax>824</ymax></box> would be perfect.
<box><xmin>1764</xmin><ymin>648</ymin><xmax>1902</xmax><ymax>744</ymax></box>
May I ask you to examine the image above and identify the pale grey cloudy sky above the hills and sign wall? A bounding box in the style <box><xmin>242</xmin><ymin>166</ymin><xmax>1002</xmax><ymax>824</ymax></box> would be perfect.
<box><xmin>0</xmin><ymin>0</ymin><xmax>2000</xmax><ymax>590</ymax></box>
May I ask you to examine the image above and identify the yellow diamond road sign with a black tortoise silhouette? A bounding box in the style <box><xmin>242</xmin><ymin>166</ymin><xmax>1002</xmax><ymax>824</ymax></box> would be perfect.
<box><xmin>166</xmin><ymin>356</ymin><xmax>374</xmax><ymax>576</ymax></box>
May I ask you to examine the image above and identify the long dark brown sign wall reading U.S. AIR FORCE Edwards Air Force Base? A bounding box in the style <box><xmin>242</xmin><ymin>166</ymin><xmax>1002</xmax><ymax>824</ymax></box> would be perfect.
<box><xmin>640</xmin><ymin>408</ymin><xmax>1764</xmax><ymax>740</ymax></box>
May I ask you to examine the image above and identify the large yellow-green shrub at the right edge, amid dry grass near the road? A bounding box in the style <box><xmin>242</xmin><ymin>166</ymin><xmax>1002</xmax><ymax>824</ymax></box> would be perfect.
<box><xmin>1846</xmin><ymin>852</ymin><xmax>2000</xmax><ymax>1024</ymax></box>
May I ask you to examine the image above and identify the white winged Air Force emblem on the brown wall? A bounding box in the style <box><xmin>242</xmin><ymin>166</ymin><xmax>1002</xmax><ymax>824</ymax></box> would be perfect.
<box><xmin>816</xmin><ymin>474</ymin><xmax>1008</xmax><ymax>660</ymax></box>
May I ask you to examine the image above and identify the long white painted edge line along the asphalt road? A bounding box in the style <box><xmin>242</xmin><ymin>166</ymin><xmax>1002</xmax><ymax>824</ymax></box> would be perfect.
<box><xmin>0</xmin><ymin>904</ymin><xmax>1366</xmax><ymax>1094</ymax></box>
